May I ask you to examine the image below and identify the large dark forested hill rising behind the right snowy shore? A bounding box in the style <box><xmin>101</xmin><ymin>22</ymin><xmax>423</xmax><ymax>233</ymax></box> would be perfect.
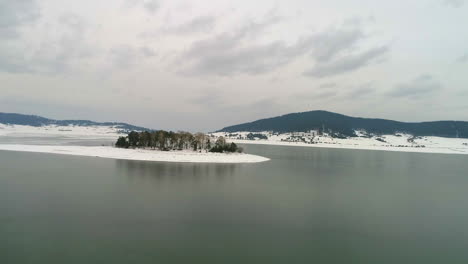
<box><xmin>219</xmin><ymin>111</ymin><xmax>468</xmax><ymax>138</ymax></box>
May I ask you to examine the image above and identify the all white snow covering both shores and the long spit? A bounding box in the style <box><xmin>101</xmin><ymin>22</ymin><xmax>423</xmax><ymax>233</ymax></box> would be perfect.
<box><xmin>0</xmin><ymin>124</ymin><xmax>468</xmax><ymax>159</ymax></box>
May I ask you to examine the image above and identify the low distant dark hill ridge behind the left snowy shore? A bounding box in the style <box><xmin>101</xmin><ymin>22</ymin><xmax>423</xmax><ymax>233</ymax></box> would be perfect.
<box><xmin>0</xmin><ymin>113</ymin><xmax>149</xmax><ymax>131</ymax></box>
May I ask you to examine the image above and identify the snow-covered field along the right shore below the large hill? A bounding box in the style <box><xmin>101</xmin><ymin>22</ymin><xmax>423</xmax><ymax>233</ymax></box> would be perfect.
<box><xmin>211</xmin><ymin>131</ymin><xmax>468</xmax><ymax>154</ymax></box>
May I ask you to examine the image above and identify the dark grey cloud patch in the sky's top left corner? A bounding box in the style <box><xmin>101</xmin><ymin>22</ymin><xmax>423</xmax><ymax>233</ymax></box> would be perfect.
<box><xmin>0</xmin><ymin>0</ymin><xmax>40</xmax><ymax>40</ymax></box>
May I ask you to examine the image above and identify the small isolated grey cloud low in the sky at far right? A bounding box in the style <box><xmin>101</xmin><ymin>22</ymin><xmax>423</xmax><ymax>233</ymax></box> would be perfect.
<box><xmin>388</xmin><ymin>75</ymin><xmax>442</xmax><ymax>98</ymax></box>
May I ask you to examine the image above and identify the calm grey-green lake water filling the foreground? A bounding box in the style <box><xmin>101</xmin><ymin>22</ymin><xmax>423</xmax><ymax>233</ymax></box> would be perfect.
<box><xmin>0</xmin><ymin>145</ymin><xmax>468</xmax><ymax>264</ymax></box>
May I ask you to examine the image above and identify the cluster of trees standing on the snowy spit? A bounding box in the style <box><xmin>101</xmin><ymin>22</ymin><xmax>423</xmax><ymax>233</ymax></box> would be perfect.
<box><xmin>115</xmin><ymin>130</ymin><xmax>242</xmax><ymax>152</ymax></box>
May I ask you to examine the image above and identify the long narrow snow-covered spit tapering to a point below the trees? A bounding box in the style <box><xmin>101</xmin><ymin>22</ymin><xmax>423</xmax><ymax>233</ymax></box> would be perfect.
<box><xmin>0</xmin><ymin>144</ymin><xmax>269</xmax><ymax>163</ymax></box>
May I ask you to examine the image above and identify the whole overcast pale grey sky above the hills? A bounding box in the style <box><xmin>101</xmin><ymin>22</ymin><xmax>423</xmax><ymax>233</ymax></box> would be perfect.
<box><xmin>0</xmin><ymin>0</ymin><xmax>468</xmax><ymax>132</ymax></box>
